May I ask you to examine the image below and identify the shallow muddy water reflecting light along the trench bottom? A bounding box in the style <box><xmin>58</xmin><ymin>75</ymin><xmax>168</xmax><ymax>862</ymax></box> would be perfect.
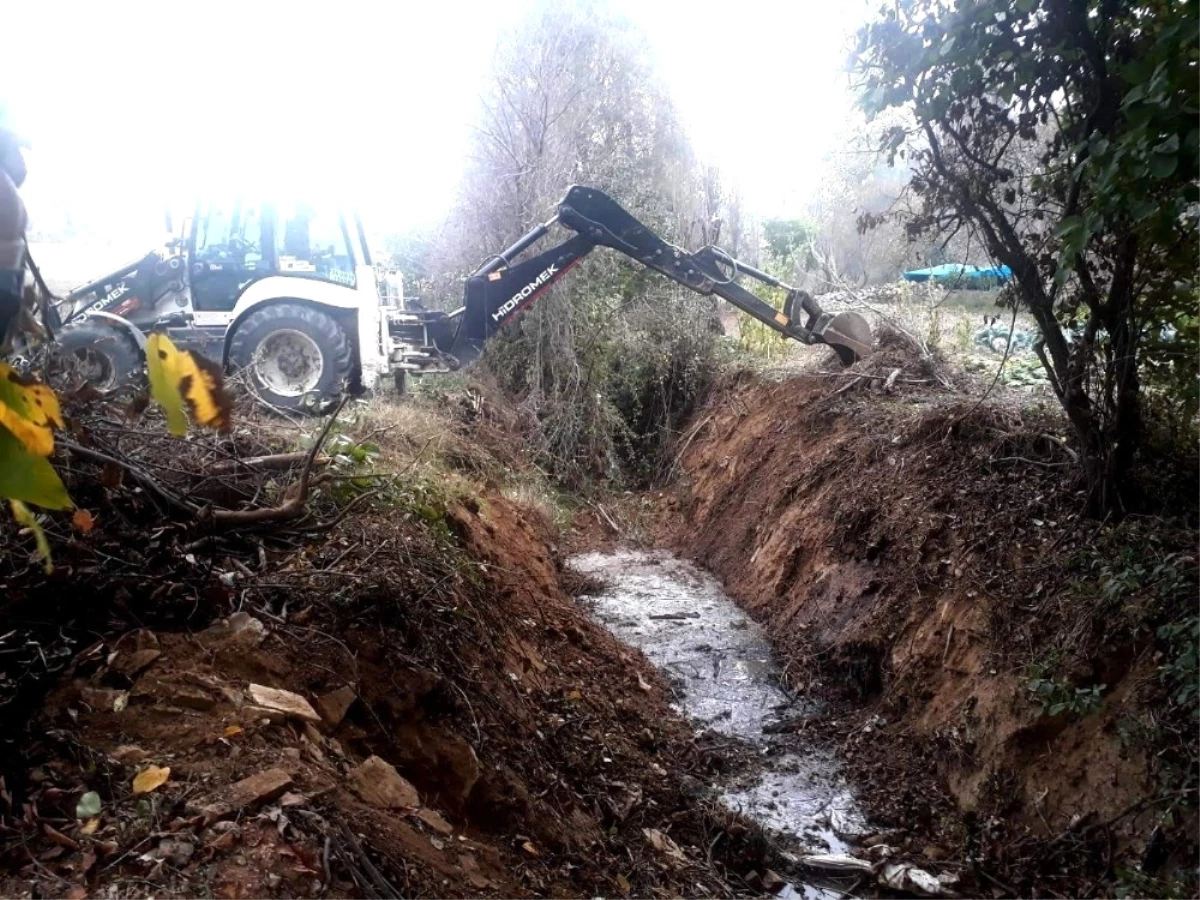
<box><xmin>568</xmin><ymin>551</ymin><xmax>865</xmax><ymax>899</ymax></box>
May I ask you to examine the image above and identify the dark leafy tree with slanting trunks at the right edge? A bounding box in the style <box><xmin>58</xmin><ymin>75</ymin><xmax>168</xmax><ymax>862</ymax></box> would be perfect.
<box><xmin>859</xmin><ymin>0</ymin><xmax>1200</xmax><ymax>514</ymax></box>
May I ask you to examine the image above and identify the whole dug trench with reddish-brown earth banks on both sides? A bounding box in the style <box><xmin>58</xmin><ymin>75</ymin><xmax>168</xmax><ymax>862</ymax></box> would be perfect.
<box><xmin>0</xmin><ymin>354</ymin><xmax>1195</xmax><ymax>900</ymax></box>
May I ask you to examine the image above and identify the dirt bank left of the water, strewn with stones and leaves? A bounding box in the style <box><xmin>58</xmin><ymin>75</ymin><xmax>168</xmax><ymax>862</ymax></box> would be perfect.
<box><xmin>0</xmin><ymin>475</ymin><xmax>767</xmax><ymax>900</ymax></box>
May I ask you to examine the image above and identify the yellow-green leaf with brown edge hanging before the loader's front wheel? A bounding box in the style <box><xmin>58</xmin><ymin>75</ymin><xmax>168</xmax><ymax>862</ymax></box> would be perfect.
<box><xmin>146</xmin><ymin>334</ymin><xmax>233</xmax><ymax>437</ymax></box>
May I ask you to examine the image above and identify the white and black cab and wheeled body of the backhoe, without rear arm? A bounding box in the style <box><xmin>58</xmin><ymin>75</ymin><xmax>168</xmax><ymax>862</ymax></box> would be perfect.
<box><xmin>60</xmin><ymin>198</ymin><xmax>391</xmax><ymax>409</ymax></box>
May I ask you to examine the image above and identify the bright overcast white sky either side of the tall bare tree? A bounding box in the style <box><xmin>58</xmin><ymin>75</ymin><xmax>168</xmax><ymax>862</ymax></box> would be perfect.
<box><xmin>0</xmin><ymin>0</ymin><xmax>868</xmax><ymax>247</ymax></box>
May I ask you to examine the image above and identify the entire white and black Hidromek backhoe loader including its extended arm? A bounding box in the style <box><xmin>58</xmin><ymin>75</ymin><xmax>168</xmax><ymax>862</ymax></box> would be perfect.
<box><xmin>52</xmin><ymin>186</ymin><xmax>871</xmax><ymax>409</ymax></box>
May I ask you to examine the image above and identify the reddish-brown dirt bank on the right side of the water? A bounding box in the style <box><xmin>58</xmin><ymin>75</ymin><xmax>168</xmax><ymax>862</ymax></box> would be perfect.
<box><xmin>664</xmin><ymin>364</ymin><xmax>1195</xmax><ymax>888</ymax></box>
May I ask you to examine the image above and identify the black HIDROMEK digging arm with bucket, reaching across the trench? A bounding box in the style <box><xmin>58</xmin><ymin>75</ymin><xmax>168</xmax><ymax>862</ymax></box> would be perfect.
<box><xmin>438</xmin><ymin>186</ymin><xmax>871</xmax><ymax>366</ymax></box>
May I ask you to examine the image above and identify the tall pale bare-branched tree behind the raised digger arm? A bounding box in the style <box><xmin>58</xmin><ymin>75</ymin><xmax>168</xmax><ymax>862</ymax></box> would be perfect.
<box><xmin>431</xmin><ymin>0</ymin><xmax>727</xmax><ymax>487</ymax></box>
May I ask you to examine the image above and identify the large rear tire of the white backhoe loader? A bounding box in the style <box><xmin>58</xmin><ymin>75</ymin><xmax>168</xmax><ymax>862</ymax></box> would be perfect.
<box><xmin>229</xmin><ymin>304</ymin><xmax>353</xmax><ymax>412</ymax></box>
